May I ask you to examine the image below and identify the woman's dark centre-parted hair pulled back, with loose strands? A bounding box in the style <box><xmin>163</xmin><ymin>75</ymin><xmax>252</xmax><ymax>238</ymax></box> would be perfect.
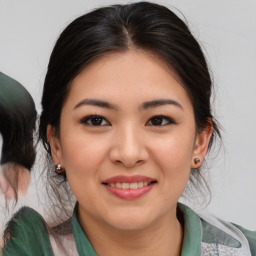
<box><xmin>39</xmin><ymin>2</ymin><xmax>220</xmax><ymax>226</ymax></box>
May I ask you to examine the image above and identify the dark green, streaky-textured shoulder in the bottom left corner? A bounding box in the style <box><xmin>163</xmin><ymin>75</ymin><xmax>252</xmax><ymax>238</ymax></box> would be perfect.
<box><xmin>3</xmin><ymin>207</ymin><xmax>53</xmax><ymax>256</ymax></box>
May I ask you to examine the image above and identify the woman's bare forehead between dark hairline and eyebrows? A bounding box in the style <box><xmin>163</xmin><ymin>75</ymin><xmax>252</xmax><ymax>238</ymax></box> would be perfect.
<box><xmin>68</xmin><ymin>50</ymin><xmax>190</xmax><ymax>109</ymax></box>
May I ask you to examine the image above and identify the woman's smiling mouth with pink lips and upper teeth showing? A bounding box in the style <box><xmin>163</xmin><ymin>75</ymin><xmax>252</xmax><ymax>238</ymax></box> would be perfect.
<box><xmin>102</xmin><ymin>175</ymin><xmax>157</xmax><ymax>200</ymax></box>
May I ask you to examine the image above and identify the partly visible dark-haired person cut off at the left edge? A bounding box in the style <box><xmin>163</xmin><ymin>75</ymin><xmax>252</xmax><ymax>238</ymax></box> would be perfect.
<box><xmin>0</xmin><ymin>72</ymin><xmax>37</xmax><ymax>201</ymax></box>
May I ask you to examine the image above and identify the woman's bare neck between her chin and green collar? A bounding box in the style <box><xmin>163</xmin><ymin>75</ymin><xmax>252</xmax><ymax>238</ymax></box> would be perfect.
<box><xmin>79</xmin><ymin>208</ymin><xmax>183</xmax><ymax>256</ymax></box>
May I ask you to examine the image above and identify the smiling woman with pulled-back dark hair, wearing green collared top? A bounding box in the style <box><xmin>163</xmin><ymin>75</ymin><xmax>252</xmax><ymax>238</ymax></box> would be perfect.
<box><xmin>4</xmin><ymin>2</ymin><xmax>256</xmax><ymax>256</ymax></box>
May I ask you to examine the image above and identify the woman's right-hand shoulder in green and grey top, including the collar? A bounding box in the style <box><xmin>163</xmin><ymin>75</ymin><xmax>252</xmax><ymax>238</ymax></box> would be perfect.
<box><xmin>178</xmin><ymin>203</ymin><xmax>256</xmax><ymax>256</ymax></box>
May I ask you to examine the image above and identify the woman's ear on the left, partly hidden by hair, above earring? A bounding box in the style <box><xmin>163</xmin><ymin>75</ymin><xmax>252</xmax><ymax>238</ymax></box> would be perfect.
<box><xmin>47</xmin><ymin>125</ymin><xmax>62</xmax><ymax>165</ymax></box>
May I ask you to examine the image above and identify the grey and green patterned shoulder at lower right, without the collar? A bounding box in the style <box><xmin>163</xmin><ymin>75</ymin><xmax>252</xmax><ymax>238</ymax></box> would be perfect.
<box><xmin>200</xmin><ymin>213</ymin><xmax>256</xmax><ymax>255</ymax></box>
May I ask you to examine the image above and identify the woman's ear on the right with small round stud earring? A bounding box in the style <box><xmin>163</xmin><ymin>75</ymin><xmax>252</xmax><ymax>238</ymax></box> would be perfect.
<box><xmin>191</xmin><ymin>120</ymin><xmax>213</xmax><ymax>168</ymax></box>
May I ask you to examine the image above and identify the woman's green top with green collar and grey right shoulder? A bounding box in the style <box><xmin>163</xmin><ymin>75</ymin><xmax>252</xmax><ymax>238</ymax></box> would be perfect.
<box><xmin>3</xmin><ymin>204</ymin><xmax>256</xmax><ymax>256</ymax></box>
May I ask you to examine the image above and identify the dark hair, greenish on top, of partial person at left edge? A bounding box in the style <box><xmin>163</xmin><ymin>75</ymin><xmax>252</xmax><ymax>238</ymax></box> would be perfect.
<box><xmin>0</xmin><ymin>72</ymin><xmax>37</xmax><ymax>202</ymax></box>
